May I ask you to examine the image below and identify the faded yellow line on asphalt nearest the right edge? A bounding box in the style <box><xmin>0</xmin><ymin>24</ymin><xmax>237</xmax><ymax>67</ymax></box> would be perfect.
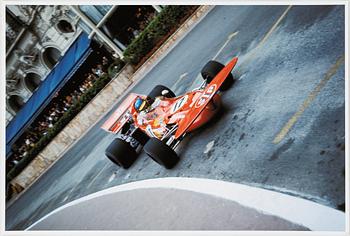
<box><xmin>273</xmin><ymin>55</ymin><xmax>345</xmax><ymax>144</ymax></box>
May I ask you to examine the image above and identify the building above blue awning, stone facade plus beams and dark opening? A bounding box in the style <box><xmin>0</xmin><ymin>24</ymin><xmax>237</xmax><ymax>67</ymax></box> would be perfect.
<box><xmin>6</xmin><ymin>5</ymin><xmax>163</xmax><ymax>124</ymax></box>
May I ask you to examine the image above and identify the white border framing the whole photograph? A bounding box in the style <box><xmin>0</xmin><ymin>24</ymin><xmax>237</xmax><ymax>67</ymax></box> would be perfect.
<box><xmin>0</xmin><ymin>0</ymin><xmax>350</xmax><ymax>235</ymax></box>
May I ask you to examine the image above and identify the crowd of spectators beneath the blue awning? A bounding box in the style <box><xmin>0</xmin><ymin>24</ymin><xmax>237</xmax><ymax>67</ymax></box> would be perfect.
<box><xmin>8</xmin><ymin>57</ymin><xmax>110</xmax><ymax>168</ymax></box>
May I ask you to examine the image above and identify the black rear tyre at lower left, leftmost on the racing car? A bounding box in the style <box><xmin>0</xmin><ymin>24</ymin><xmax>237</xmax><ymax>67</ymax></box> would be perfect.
<box><xmin>105</xmin><ymin>138</ymin><xmax>137</xmax><ymax>169</ymax></box>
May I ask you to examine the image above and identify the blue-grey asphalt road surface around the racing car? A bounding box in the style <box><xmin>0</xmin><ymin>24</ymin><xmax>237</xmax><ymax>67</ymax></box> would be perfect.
<box><xmin>6</xmin><ymin>6</ymin><xmax>345</xmax><ymax>230</ymax></box>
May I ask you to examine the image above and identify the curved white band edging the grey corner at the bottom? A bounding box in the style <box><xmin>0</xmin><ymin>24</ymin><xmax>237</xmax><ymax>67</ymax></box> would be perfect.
<box><xmin>26</xmin><ymin>177</ymin><xmax>345</xmax><ymax>231</ymax></box>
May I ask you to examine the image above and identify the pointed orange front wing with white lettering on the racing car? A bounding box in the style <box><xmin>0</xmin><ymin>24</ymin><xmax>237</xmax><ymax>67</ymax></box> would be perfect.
<box><xmin>175</xmin><ymin>57</ymin><xmax>238</xmax><ymax>139</ymax></box>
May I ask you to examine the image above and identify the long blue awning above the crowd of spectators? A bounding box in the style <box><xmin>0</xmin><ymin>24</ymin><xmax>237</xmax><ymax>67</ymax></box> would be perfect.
<box><xmin>6</xmin><ymin>33</ymin><xmax>92</xmax><ymax>155</ymax></box>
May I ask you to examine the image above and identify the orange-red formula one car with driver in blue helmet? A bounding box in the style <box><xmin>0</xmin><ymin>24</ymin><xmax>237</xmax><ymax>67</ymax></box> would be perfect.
<box><xmin>102</xmin><ymin>57</ymin><xmax>238</xmax><ymax>169</ymax></box>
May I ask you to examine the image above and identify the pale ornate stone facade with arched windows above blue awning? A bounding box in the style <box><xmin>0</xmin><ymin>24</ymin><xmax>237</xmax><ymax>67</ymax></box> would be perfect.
<box><xmin>6</xmin><ymin>5</ymin><xmax>82</xmax><ymax>124</ymax></box>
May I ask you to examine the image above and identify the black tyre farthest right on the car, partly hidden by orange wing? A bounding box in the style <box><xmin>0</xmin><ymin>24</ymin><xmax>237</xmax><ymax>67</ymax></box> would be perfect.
<box><xmin>201</xmin><ymin>61</ymin><xmax>234</xmax><ymax>91</ymax></box>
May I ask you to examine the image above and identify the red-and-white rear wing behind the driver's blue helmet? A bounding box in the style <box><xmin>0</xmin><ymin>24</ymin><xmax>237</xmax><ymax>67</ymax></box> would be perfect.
<box><xmin>101</xmin><ymin>93</ymin><xmax>142</xmax><ymax>133</ymax></box>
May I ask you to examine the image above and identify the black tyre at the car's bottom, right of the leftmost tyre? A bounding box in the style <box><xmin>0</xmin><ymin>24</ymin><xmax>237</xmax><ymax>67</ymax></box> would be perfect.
<box><xmin>143</xmin><ymin>138</ymin><xmax>179</xmax><ymax>169</ymax></box>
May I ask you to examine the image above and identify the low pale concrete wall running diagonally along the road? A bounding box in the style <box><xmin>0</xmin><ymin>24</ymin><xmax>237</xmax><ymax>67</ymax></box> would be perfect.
<box><xmin>11</xmin><ymin>6</ymin><xmax>213</xmax><ymax>193</ymax></box>
